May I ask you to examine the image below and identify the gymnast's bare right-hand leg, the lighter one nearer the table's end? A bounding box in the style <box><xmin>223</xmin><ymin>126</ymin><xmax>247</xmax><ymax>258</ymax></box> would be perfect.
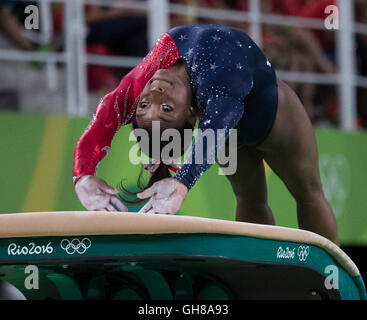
<box><xmin>257</xmin><ymin>81</ymin><xmax>338</xmax><ymax>244</ymax></box>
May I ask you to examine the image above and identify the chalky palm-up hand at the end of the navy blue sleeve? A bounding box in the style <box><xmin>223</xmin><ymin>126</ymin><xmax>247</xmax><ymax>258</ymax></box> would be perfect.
<box><xmin>137</xmin><ymin>178</ymin><xmax>188</xmax><ymax>214</ymax></box>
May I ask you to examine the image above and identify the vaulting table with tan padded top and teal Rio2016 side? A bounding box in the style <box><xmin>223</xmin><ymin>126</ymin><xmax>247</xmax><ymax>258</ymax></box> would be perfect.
<box><xmin>0</xmin><ymin>211</ymin><xmax>367</xmax><ymax>300</ymax></box>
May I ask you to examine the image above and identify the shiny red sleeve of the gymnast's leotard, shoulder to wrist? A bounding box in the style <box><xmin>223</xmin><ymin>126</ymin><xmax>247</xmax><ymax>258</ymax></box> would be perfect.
<box><xmin>73</xmin><ymin>34</ymin><xmax>179</xmax><ymax>184</ymax></box>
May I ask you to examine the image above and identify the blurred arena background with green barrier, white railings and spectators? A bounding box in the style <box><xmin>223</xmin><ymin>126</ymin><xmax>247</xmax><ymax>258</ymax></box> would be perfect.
<box><xmin>0</xmin><ymin>0</ymin><xmax>367</xmax><ymax>278</ymax></box>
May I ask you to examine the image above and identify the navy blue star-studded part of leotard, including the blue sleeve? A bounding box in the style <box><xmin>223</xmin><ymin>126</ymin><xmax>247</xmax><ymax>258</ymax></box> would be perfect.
<box><xmin>168</xmin><ymin>25</ymin><xmax>278</xmax><ymax>189</ymax></box>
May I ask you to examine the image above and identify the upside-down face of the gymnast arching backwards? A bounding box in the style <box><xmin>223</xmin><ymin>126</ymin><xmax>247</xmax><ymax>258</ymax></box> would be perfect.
<box><xmin>135</xmin><ymin>64</ymin><xmax>196</xmax><ymax>129</ymax></box>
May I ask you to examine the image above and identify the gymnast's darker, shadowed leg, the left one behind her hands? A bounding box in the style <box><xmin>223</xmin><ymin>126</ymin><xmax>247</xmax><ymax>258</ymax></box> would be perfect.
<box><xmin>217</xmin><ymin>145</ymin><xmax>274</xmax><ymax>224</ymax></box>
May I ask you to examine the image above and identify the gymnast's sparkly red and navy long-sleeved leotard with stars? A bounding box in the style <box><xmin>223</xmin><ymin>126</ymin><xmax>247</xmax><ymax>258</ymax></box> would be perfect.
<box><xmin>73</xmin><ymin>25</ymin><xmax>278</xmax><ymax>189</ymax></box>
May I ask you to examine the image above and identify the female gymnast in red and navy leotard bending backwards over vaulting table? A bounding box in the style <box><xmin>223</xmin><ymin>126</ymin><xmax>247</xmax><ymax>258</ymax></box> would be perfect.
<box><xmin>73</xmin><ymin>25</ymin><xmax>338</xmax><ymax>244</ymax></box>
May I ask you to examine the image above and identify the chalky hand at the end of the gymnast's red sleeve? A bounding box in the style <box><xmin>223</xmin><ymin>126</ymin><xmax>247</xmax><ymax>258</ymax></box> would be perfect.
<box><xmin>75</xmin><ymin>175</ymin><xmax>128</xmax><ymax>212</ymax></box>
